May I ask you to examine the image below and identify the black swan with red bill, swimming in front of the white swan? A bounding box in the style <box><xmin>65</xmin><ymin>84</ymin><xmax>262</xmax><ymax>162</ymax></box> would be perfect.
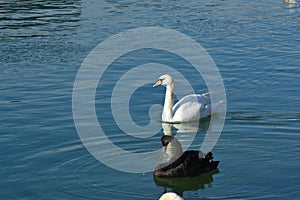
<box><xmin>153</xmin><ymin>135</ymin><xmax>219</xmax><ymax>178</ymax></box>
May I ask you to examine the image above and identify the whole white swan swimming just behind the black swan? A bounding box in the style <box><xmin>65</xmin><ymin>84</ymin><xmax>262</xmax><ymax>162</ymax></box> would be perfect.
<box><xmin>153</xmin><ymin>74</ymin><xmax>223</xmax><ymax>123</ymax></box>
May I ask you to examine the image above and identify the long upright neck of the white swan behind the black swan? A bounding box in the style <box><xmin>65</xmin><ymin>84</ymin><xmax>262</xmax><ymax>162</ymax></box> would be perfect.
<box><xmin>162</xmin><ymin>83</ymin><xmax>174</xmax><ymax>122</ymax></box>
